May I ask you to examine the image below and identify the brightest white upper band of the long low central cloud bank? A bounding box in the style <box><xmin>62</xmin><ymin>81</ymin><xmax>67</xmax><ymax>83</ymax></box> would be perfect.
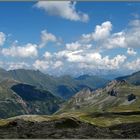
<box><xmin>58</xmin><ymin>50</ymin><xmax>126</xmax><ymax>69</ymax></box>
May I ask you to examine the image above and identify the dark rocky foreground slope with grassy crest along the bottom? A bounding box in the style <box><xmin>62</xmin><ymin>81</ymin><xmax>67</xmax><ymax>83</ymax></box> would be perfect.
<box><xmin>0</xmin><ymin>113</ymin><xmax>140</xmax><ymax>139</ymax></box>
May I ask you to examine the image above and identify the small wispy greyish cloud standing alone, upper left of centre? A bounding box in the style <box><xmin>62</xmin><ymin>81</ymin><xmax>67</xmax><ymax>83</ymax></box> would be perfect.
<box><xmin>39</xmin><ymin>30</ymin><xmax>57</xmax><ymax>48</ymax></box>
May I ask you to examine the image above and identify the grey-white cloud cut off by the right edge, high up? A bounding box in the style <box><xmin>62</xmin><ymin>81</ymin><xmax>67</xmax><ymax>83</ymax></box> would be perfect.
<box><xmin>104</xmin><ymin>19</ymin><xmax>140</xmax><ymax>49</ymax></box>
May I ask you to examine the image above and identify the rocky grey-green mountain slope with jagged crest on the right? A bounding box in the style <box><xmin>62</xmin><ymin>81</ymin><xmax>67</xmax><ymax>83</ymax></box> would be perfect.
<box><xmin>59</xmin><ymin>80</ymin><xmax>140</xmax><ymax>113</ymax></box>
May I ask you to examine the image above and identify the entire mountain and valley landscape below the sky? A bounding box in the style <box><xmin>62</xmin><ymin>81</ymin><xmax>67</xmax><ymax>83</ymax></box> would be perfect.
<box><xmin>0</xmin><ymin>70</ymin><xmax>140</xmax><ymax>138</ymax></box>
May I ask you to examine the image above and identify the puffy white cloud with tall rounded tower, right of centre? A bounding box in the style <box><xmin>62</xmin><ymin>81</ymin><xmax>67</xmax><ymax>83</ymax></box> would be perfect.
<box><xmin>80</xmin><ymin>21</ymin><xmax>127</xmax><ymax>49</ymax></box>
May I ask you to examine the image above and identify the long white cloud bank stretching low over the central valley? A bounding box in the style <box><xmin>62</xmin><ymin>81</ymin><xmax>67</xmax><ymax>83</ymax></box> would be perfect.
<box><xmin>33</xmin><ymin>44</ymin><xmax>127</xmax><ymax>75</ymax></box>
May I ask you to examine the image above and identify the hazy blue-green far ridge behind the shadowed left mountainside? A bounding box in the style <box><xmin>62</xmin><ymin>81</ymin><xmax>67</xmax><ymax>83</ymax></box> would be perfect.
<box><xmin>0</xmin><ymin>69</ymin><xmax>108</xmax><ymax>99</ymax></box>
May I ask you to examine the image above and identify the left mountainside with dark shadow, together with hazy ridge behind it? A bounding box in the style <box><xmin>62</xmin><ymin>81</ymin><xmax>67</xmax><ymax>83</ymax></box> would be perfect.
<box><xmin>0</xmin><ymin>69</ymin><xmax>108</xmax><ymax>118</ymax></box>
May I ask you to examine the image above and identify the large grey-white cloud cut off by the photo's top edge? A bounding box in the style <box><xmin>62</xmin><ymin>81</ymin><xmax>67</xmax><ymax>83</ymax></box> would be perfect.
<box><xmin>35</xmin><ymin>1</ymin><xmax>89</xmax><ymax>22</ymax></box>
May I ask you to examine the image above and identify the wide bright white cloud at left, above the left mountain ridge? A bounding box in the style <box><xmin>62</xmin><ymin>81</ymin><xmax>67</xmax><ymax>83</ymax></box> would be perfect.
<box><xmin>2</xmin><ymin>43</ymin><xmax>38</xmax><ymax>58</ymax></box>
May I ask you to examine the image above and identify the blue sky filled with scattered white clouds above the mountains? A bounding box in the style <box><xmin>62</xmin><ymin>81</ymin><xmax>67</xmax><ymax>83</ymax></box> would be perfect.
<box><xmin>0</xmin><ymin>1</ymin><xmax>140</xmax><ymax>76</ymax></box>
